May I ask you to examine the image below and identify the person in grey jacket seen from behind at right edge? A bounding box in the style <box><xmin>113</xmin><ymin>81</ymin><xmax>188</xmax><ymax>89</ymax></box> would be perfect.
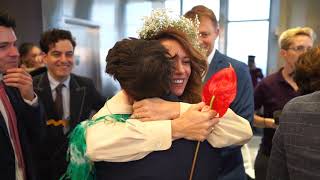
<box><xmin>267</xmin><ymin>47</ymin><xmax>320</xmax><ymax>180</ymax></box>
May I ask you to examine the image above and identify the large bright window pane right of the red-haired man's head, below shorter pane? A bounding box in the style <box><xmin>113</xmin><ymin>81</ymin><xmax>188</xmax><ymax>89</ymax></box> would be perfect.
<box><xmin>227</xmin><ymin>21</ymin><xmax>269</xmax><ymax>74</ymax></box>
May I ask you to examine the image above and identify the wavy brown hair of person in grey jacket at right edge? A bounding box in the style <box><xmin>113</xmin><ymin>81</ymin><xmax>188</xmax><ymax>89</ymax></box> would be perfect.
<box><xmin>294</xmin><ymin>47</ymin><xmax>320</xmax><ymax>94</ymax></box>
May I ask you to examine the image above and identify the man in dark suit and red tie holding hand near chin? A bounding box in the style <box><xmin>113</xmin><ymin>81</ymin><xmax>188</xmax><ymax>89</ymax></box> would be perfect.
<box><xmin>0</xmin><ymin>11</ymin><xmax>44</xmax><ymax>180</ymax></box>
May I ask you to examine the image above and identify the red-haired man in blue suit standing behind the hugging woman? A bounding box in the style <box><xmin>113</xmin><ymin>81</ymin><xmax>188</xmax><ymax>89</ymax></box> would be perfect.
<box><xmin>184</xmin><ymin>5</ymin><xmax>254</xmax><ymax>180</ymax></box>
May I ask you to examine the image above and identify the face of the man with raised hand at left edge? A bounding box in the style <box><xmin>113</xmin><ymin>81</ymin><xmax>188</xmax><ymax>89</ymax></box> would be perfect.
<box><xmin>0</xmin><ymin>26</ymin><xmax>19</xmax><ymax>73</ymax></box>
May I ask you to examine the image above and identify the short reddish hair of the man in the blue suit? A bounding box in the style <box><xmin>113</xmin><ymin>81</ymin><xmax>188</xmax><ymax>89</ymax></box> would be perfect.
<box><xmin>184</xmin><ymin>5</ymin><xmax>218</xmax><ymax>28</ymax></box>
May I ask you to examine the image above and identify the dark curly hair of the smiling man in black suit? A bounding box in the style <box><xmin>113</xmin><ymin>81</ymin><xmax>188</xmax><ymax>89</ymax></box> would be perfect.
<box><xmin>40</xmin><ymin>29</ymin><xmax>76</xmax><ymax>54</ymax></box>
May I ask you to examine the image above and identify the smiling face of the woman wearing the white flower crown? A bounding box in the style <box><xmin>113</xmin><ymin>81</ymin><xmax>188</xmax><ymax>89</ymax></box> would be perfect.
<box><xmin>161</xmin><ymin>39</ymin><xmax>191</xmax><ymax>96</ymax></box>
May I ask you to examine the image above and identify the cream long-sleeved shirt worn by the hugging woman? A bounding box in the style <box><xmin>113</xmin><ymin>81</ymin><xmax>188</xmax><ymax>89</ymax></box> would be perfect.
<box><xmin>86</xmin><ymin>91</ymin><xmax>252</xmax><ymax>162</ymax></box>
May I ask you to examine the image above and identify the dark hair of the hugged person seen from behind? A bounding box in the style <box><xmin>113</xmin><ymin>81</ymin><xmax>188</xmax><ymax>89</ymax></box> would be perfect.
<box><xmin>106</xmin><ymin>39</ymin><xmax>173</xmax><ymax>100</ymax></box>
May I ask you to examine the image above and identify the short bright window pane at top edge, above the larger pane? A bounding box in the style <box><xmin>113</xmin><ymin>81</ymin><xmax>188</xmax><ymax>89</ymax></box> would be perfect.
<box><xmin>228</xmin><ymin>0</ymin><xmax>270</xmax><ymax>21</ymax></box>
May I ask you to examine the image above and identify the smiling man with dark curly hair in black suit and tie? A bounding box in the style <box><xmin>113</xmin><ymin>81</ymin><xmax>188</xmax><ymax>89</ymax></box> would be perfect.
<box><xmin>33</xmin><ymin>29</ymin><xmax>105</xmax><ymax>180</ymax></box>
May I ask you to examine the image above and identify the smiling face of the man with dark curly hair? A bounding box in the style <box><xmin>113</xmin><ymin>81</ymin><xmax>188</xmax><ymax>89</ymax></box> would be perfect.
<box><xmin>44</xmin><ymin>40</ymin><xmax>74</xmax><ymax>81</ymax></box>
